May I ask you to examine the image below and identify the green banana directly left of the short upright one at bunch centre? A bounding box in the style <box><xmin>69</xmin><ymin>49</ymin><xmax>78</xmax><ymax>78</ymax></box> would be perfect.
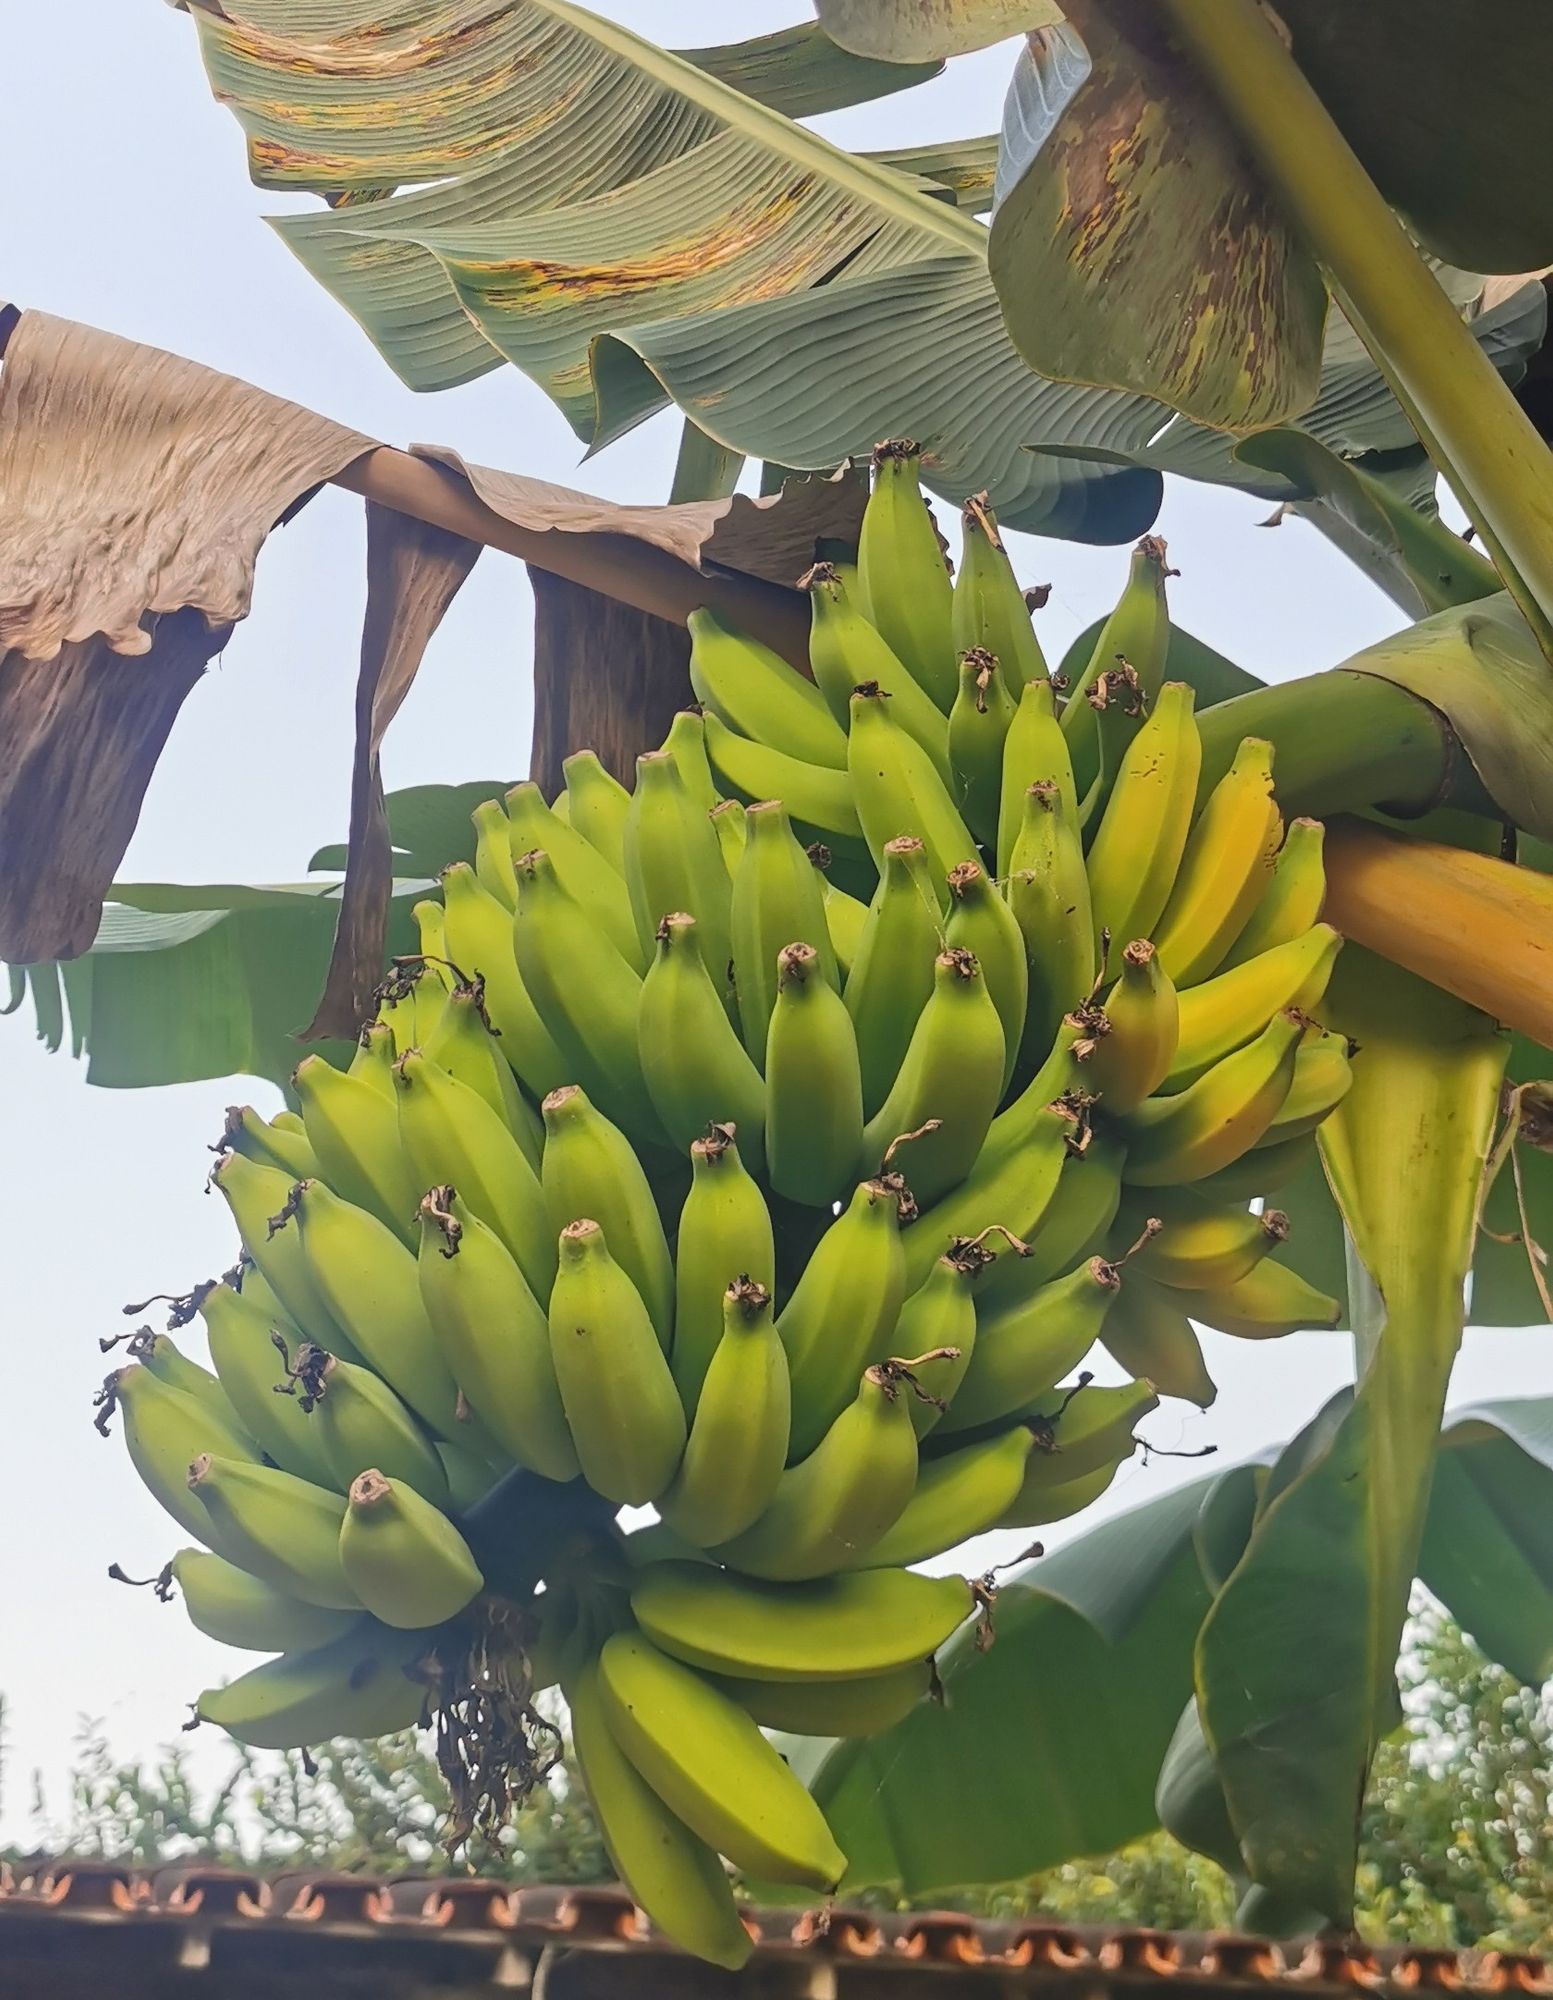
<box><xmin>636</xmin><ymin>916</ymin><xmax>768</xmax><ymax>1170</ymax></box>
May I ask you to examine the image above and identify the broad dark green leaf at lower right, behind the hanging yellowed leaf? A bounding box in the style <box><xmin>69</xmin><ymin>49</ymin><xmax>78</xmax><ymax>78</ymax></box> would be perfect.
<box><xmin>812</xmin><ymin>1392</ymin><xmax>1553</xmax><ymax>1898</ymax></box>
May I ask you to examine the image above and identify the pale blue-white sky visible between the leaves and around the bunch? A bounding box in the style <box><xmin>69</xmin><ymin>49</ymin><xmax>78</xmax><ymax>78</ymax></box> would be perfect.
<box><xmin>0</xmin><ymin>0</ymin><xmax>1553</xmax><ymax>1840</ymax></box>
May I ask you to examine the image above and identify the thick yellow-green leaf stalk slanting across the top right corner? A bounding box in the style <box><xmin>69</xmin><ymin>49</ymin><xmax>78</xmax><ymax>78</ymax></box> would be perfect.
<box><xmin>1167</xmin><ymin>0</ymin><xmax>1553</xmax><ymax>658</ymax></box>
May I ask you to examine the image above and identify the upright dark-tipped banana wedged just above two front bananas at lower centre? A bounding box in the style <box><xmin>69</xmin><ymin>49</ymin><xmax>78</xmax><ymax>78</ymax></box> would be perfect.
<box><xmin>668</xmin><ymin>1126</ymin><xmax>777</xmax><ymax>1416</ymax></box>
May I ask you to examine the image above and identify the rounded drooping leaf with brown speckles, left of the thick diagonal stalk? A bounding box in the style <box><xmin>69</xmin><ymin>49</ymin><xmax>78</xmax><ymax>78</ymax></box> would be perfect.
<box><xmin>989</xmin><ymin>0</ymin><xmax>1327</xmax><ymax>432</ymax></box>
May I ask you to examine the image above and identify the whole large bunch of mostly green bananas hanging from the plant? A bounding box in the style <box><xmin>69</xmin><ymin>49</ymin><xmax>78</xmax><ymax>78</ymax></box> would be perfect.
<box><xmin>100</xmin><ymin>446</ymin><xmax>1351</xmax><ymax>1964</ymax></box>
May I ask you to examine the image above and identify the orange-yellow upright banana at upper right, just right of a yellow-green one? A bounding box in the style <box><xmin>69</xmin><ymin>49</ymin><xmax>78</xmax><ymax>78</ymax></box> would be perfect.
<box><xmin>1155</xmin><ymin>736</ymin><xmax>1283</xmax><ymax>986</ymax></box>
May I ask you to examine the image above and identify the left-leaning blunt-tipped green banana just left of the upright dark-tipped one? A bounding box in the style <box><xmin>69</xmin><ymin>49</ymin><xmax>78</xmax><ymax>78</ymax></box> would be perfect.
<box><xmin>534</xmin><ymin>1084</ymin><xmax>674</xmax><ymax>1354</ymax></box>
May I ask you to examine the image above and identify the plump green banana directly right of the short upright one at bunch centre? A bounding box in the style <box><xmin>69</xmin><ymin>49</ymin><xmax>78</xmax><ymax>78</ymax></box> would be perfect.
<box><xmin>859</xmin><ymin>952</ymin><xmax>1003</xmax><ymax>1202</ymax></box>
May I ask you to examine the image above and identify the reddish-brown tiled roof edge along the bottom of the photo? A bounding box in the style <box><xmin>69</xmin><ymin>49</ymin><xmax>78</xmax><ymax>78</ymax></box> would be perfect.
<box><xmin>0</xmin><ymin>1860</ymin><xmax>1553</xmax><ymax>2000</ymax></box>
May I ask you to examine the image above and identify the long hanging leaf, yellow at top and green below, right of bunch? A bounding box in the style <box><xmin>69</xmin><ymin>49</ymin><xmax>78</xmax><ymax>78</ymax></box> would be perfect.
<box><xmin>1195</xmin><ymin>946</ymin><xmax>1507</xmax><ymax>1924</ymax></box>
